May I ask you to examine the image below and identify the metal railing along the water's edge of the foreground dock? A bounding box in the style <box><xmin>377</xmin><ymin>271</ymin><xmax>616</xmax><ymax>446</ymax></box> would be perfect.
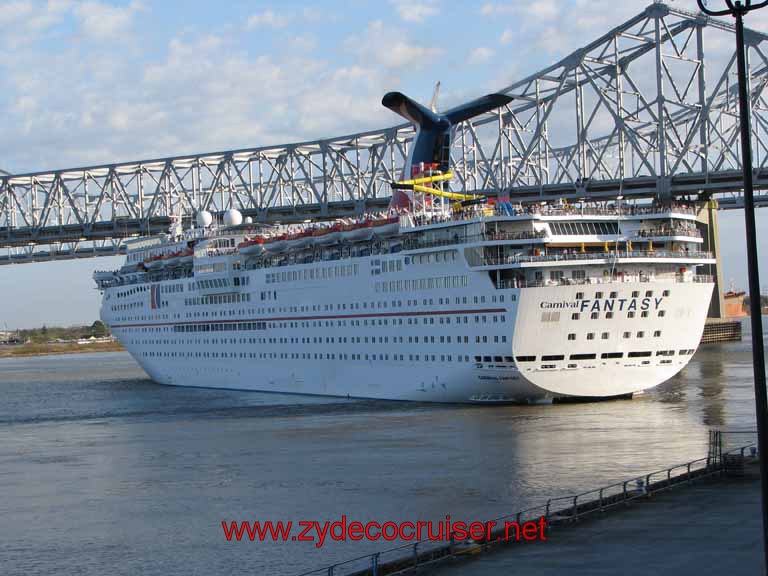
<box><xmin>299</xmin><ymin>442</ymin><xmax>758</xmax><ymax>576</ymax></box>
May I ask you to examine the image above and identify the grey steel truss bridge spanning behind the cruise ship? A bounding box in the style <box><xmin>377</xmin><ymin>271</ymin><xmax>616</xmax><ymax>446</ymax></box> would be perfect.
<box><xmin>0</xmin><ymin>3</ymin><xmax>768</xmax><ymax>263</ymax></box>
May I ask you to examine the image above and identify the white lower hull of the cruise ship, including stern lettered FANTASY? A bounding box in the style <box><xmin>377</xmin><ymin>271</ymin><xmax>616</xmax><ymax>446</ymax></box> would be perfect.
<box><xmin>103</xmin><ymin>274</ymin><xmax>713</xmax><ymax>404</ymax></box>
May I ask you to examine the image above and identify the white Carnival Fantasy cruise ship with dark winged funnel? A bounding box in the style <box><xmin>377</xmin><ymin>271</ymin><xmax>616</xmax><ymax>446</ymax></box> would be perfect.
<box><xmin>94</xmin><ymin>93</ymin><xmax>714</xmax><ymax>404</ymax></box>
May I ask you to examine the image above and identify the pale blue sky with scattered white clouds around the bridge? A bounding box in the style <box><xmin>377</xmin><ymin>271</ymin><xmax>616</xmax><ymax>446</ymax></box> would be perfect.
<box><xmin>0</xmin><ymin>0</ymin><xmax>768</xmax><ymax>329</ymax></box>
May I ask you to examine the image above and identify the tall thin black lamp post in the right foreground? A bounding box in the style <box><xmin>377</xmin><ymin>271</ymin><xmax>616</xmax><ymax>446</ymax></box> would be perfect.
<box><xmin>697</xmin><ymin>0</ymin><xmax>768</xmax><ymax>570</ymax></box>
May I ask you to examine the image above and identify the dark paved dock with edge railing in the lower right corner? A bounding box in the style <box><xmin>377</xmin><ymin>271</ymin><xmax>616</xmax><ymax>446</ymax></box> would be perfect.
<box><xmin>301</xmin><ymin>433</ymin><xmax>762</xmax><ymax>576</ymax></box>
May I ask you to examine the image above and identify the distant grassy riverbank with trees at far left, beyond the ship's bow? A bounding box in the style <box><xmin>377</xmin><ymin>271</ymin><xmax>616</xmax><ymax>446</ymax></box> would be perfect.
<box><xmin>0</xmin><ymin>320</ymin><xmax>124</xmax><ymax>358</ymax></box>
